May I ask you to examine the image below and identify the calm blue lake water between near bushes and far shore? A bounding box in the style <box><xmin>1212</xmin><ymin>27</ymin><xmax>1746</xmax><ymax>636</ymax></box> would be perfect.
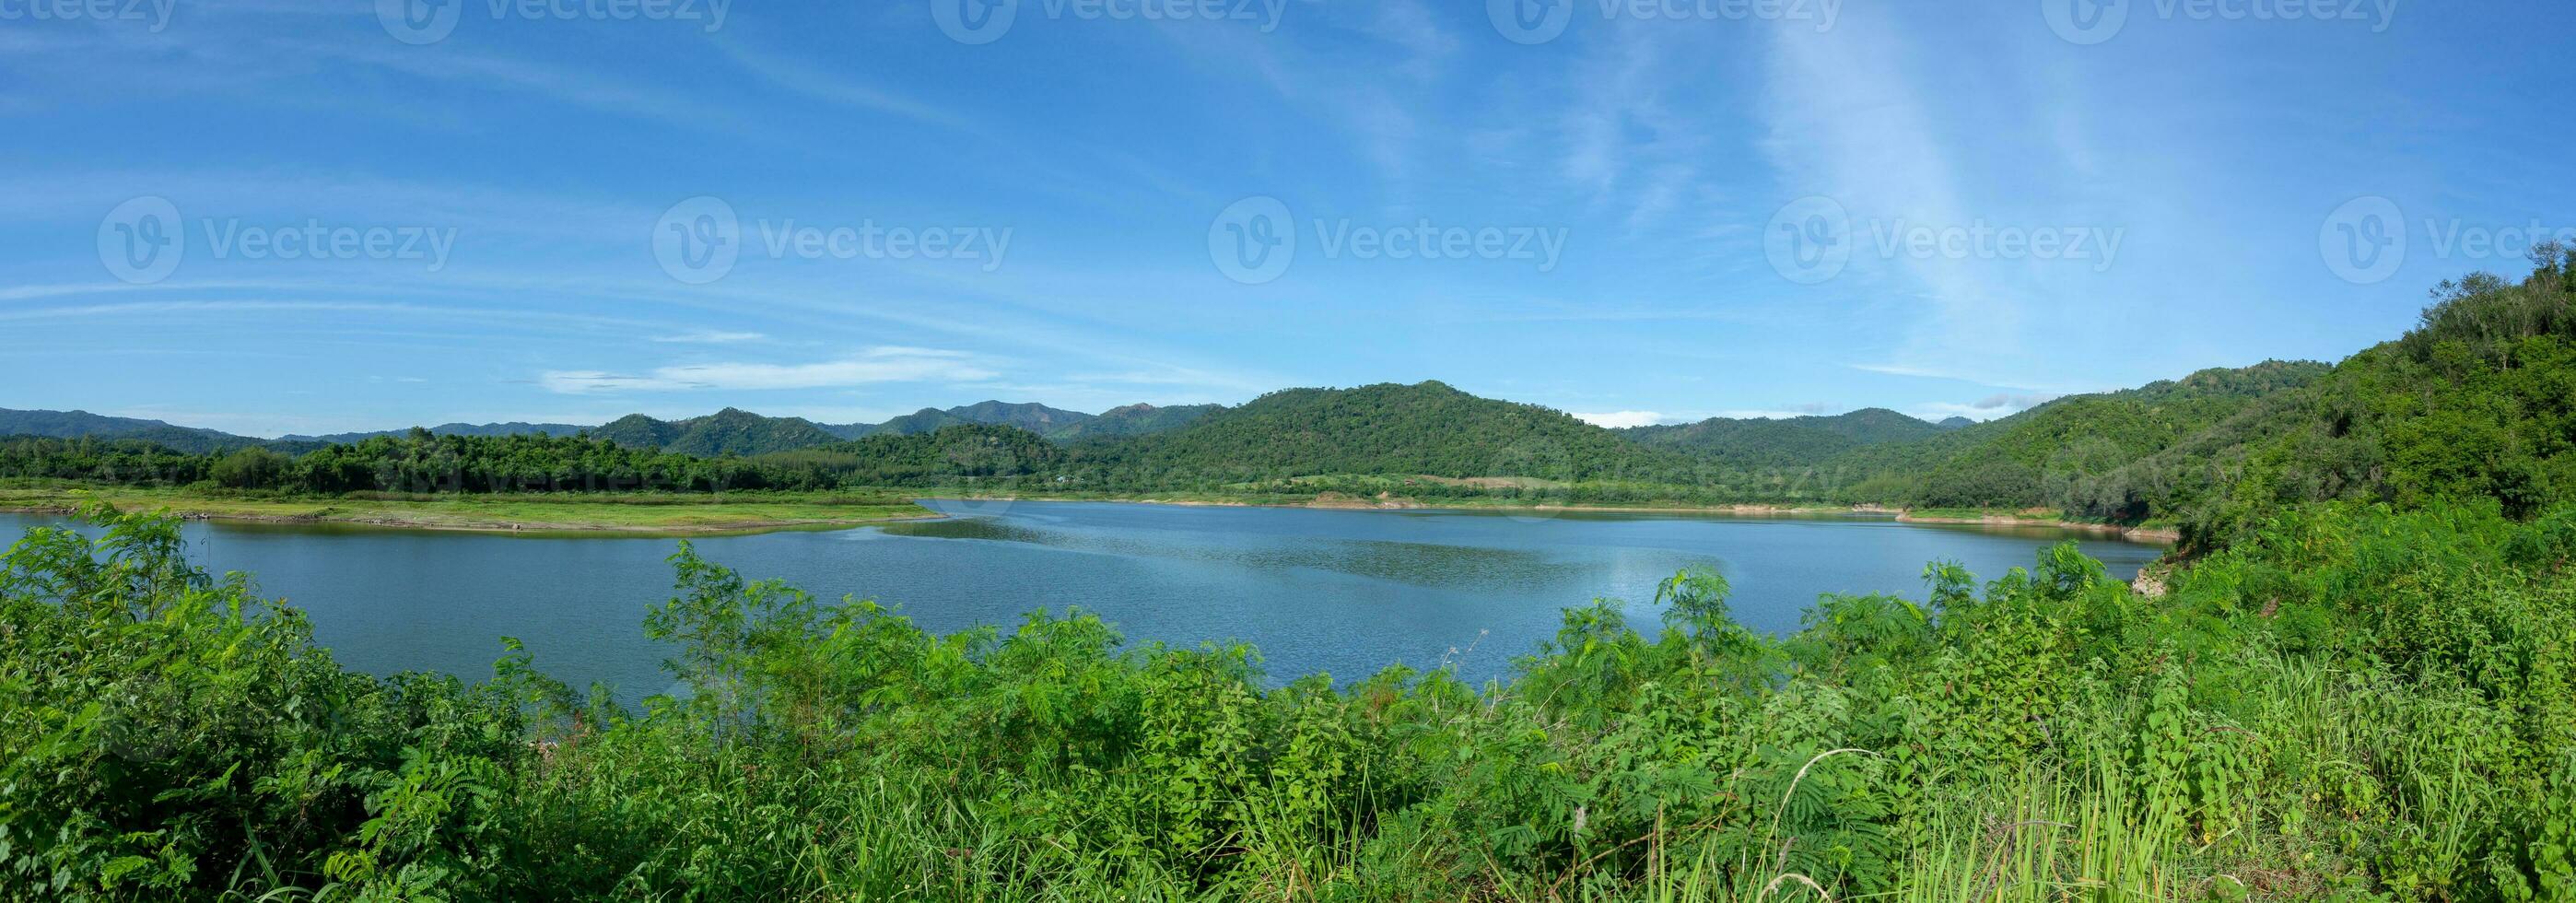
<box><xmin>0</xmin><ymin>501</ymin><xmax>2164</xmax><ymax>698</ymax></box>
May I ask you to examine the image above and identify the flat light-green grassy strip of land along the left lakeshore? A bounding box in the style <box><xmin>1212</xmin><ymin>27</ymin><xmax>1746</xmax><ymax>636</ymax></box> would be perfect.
<box><xmin>0</xmin><ymin>487</ymin><xmax>938</xmax><ymax>533</ymax></box>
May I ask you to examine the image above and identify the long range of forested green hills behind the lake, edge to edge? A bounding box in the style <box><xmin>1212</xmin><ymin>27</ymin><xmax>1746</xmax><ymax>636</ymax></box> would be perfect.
<box><xmin>0</xmin><ymin>241</ymin><xmax>2576</xmax><ymax>548</ymax></box>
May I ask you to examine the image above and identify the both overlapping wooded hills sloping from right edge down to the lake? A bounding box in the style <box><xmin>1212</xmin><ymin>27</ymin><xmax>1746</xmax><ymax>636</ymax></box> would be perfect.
<box><xmin>1821</xmin><ymin>244</ymin><xmax>2576</xmax><ymax>545</ymax></box>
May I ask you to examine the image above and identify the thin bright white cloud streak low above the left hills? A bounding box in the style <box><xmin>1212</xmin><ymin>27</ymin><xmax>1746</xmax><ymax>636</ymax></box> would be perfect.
<box><xmin>538</xmin><ymin>347</ymin><xmax>1000</xmax><ymax>393</ymax></box>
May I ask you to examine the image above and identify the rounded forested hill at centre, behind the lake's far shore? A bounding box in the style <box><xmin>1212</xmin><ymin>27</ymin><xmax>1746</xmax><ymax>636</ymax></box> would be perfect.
<box><xmin>1082</xmin><ymin>381</ymin><xmax>1690</xmax><ymax>481</ymax></box>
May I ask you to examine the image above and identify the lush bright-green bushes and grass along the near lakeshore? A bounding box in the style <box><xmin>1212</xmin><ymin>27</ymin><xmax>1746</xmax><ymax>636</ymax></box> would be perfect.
<box><xmin>0</xmin><ymin>504</ymin><xmax>2576</xmax><ymax>900</ymax></box>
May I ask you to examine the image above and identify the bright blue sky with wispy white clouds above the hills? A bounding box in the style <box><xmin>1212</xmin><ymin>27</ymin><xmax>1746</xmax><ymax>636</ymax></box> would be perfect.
<box><xmin>0</xmin><ymin>0</ymin><xmax>2576</xmax><ymax>435</ymax></box>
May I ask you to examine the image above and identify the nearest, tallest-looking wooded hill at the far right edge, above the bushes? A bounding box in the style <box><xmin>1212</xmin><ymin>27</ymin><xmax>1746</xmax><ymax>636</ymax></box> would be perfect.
<box><xmin>2068</xmin><ymin>258</ymin><xmax>2576</xmax><ymax>543</ymax></box>
